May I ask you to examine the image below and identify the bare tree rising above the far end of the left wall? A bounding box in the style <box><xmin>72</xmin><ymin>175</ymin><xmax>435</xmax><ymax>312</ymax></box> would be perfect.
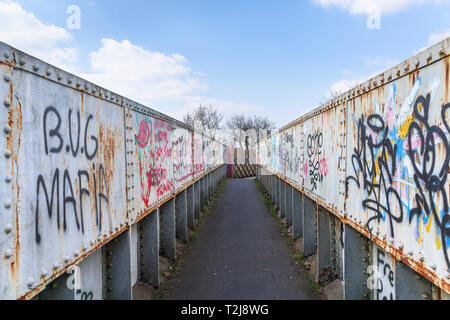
<box><xmin>183</xmin><ymin>105</ymin><xmax>223</xmax><ymax>139</ymax></box>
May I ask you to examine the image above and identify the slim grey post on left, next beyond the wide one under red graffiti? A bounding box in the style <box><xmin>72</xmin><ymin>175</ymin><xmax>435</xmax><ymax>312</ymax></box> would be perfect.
<box><xmin>159</xmin><ymin>198</ymin><xmax>177</xmax><ymax>261</ymax></box>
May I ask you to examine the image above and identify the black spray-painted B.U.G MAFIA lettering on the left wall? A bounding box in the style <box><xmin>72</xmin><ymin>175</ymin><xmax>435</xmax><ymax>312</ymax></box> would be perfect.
<box><xmin>35</xmin><ymin>106</ymin><xmax>109</xmax><ymax>244</ymax></box>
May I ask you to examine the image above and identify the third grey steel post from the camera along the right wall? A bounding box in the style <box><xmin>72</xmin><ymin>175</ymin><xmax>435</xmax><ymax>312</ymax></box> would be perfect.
<box><xmin>316</xmin><ymin>208</ymin><xmax>332</xmax><ymax>283</ymax></box>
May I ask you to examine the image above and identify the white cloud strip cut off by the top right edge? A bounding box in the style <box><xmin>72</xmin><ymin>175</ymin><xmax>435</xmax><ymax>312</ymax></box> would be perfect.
<box><xmin>312</xmin><ymin>0</ymin><xmax>448</xmax><ymax>14</ymax></box>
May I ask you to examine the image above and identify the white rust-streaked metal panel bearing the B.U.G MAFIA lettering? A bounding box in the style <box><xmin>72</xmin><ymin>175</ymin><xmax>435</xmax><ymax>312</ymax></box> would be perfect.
<box><xmin>6</xmin><ymin>63</ymin><xmax>126</xmax><ymax>297</ymax></box>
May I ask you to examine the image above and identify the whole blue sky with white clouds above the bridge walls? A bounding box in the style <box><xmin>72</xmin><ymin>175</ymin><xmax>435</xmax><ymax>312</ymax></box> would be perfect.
<box><xmin>0</xmin><ymin>0</ymin><xmax>450</xmax><ymax>126</ymax></box>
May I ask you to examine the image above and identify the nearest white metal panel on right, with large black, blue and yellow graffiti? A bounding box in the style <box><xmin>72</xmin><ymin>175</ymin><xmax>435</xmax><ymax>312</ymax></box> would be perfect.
<box><xmin>347</xmin><ymin>58</ymin><xmax>450</xmax><ymax>279</ymax></box>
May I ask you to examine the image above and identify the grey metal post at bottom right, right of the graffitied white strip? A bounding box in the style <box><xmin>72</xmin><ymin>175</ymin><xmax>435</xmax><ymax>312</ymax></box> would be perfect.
<box><xmin>395</xmin><ymin>261</ymin><xmax>433</xmax><ymax>300</ymax></box>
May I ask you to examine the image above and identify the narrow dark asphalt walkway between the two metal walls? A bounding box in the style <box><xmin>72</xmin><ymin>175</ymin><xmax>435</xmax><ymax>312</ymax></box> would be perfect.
<box><xmin>161</xmin><ymin>179</ymin><xmax>320</xmax><ymax>300</ymax></box>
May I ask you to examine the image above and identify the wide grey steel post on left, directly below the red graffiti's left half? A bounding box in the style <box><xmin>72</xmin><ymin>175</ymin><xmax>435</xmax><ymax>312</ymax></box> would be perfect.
<box><xmin>138</xmin><ymin>209</ymin><xmax>160</xmax><ymax>289</ymax></box>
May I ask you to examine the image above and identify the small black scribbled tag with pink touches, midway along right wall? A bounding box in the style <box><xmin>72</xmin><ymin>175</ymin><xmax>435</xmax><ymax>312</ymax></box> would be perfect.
<box><xmin>303</xmin><ymin>131</ymin><xmax>328</xmax><ymax>191</ymax></box>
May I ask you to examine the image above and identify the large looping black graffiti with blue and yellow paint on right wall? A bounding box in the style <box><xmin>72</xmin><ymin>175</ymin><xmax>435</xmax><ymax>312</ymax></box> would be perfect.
<box><xmin>347</xmin><ymin>78</ymin><xmax>450</xmax><ymax>267</ymax></box>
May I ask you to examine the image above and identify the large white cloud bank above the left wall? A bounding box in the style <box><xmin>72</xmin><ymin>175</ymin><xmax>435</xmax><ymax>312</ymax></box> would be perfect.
<box><xmin>0</xmin><ymin>0</ymin><xmax>262</xmax><ymax>124</ymax></box>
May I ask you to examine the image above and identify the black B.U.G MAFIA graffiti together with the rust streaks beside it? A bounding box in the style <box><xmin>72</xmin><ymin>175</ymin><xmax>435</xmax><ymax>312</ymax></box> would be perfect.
<box><xmin>35</xmin><ymin>106</ymin><xmax>110</xmax><ymax>244</ymax></box>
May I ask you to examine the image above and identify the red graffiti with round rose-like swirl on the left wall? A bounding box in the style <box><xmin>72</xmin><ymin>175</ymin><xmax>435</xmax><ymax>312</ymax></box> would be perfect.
<box><xmin>135</xmin><ymin>118</ymin><xmax>174</xmax><ymax>207</ymax></box>
